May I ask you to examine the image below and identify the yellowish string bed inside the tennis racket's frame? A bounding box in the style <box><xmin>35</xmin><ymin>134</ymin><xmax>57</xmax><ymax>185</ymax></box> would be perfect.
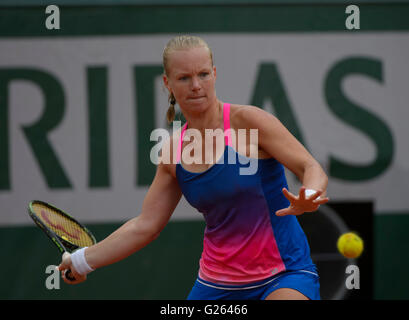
<box><xmin>33</xmin><ymin>204</ymin><xmax>94</xmax><ymax>247</ymax></box>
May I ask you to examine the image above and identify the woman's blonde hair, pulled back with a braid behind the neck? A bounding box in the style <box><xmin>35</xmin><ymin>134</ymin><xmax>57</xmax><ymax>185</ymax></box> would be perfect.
<box><xmin>163</xmin><ymin>35</ymin><xmax>213</xmax><ymax>123</ymax></box>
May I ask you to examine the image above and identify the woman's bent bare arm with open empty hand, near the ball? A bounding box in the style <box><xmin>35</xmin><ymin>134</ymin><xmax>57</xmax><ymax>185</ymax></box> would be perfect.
<box><xmin>243</xmin><ymin>107</ymin><xmax>329</xmax><ymax>216</ymax></box>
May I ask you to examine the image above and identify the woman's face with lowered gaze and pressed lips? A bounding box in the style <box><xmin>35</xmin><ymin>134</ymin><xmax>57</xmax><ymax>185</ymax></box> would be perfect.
<box><xmin>163</xmin><ymin>47</ymin><xmax>216</xmax><ymax>112</ymax></box>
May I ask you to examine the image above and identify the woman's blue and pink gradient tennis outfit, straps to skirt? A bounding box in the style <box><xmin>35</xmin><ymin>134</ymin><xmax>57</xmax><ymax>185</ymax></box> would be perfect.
<box><xmin>176</xmin><ymin>103</ymin><xmax>320</xmax><ymax>300</ymax></box>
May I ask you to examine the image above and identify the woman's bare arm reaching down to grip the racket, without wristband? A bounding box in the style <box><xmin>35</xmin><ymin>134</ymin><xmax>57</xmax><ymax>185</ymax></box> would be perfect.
<box><xmin>59</xmin><ymin>164</ymin><xmax>182</xmax><ymax>283</ymax></box>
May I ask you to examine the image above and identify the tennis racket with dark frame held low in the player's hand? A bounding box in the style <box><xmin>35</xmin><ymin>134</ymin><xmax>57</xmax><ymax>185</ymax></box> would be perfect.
<box><xmin>28</xmin><ymin>200</ymin><xmax>96</xmax><ymax>281</ymax></box>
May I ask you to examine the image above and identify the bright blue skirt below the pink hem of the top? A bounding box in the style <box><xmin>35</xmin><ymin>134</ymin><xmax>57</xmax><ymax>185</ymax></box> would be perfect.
<box><xmin>187</xmin><ymin>270</ymin><xmax>321</xmax><ymax>300</ymax></box>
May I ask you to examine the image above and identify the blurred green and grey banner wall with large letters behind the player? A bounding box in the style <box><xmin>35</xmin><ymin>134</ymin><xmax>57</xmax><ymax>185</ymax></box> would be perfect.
<box><xmin>0</xmin><ymin>0</ymin><xmax>409</xmax><ymax>299</ymax></box>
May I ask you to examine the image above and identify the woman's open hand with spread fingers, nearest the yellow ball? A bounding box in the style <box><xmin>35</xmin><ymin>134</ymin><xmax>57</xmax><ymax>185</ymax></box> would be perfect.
<box><xmin>276</xmin><ymin>186</ymin><xmax>329</xmax><ymax>217</ymax></box>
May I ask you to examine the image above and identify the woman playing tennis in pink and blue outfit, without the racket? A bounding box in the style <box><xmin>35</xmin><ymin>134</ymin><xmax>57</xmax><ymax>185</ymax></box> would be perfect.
<box><xmin>59</xmin><ymin>36</ymin><xmax>329</xmax><ymax>300</ymax></box>
